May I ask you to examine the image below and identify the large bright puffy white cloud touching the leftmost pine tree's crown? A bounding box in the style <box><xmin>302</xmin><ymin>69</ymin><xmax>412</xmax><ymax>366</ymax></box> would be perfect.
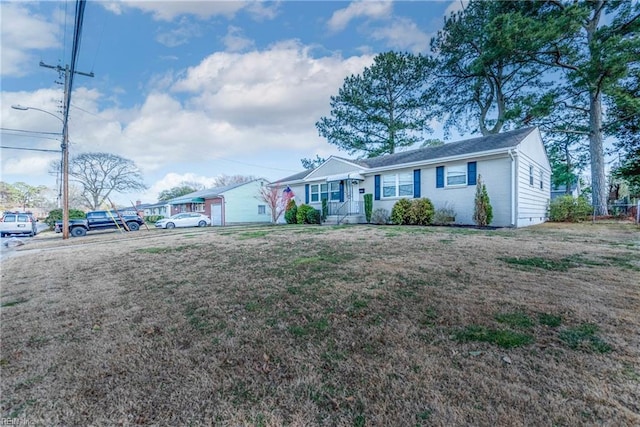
<box><xmin>173</xmin><ymin>41</ymin><xmax>373</xmax><ymax>132</ymax></box>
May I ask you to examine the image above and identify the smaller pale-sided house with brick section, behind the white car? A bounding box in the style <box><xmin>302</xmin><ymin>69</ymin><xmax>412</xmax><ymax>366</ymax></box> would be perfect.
<box><xmin>167</xmin><ymin>179</ymin><xmax>271</xmax><ymax>225</ymax></box>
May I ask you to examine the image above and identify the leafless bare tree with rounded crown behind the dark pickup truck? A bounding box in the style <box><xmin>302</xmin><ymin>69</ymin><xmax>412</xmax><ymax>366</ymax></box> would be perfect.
<box><xmin>69</xmin><ymin>153</ymin><xmax>147</xmax><ymax>209</ymax></box>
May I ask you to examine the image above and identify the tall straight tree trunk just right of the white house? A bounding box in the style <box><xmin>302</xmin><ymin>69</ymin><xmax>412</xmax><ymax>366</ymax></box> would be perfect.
<box><xmin>589</xmin><ymin>89</ymin><xmax>609</xmax><ymax>215</ymax></box>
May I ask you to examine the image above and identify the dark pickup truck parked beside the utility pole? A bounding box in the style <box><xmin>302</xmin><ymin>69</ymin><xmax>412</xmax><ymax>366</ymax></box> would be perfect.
<box><xmin>55</xmin><ymin>209</ymin><xmax>144</xmax><ymax>237</ymax></box>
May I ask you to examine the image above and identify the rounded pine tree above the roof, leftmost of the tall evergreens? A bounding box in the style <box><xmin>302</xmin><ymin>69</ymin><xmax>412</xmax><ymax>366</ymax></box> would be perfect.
<box><xmin>316</xmin><ymin>52</ymin><xmax>434</xmax><ymax>157</ymax></box>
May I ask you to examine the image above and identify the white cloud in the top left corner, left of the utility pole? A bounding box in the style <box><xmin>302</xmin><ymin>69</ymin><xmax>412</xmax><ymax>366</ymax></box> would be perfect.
<box><xmin>0</xmin><ymin>2</ymin><xmax>60</xmax><ymax>77</ymax></box>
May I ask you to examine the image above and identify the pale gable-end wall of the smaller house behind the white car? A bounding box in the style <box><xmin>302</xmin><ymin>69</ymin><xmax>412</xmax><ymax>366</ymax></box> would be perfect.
<box><xmin>223</xmin><ymin>180</ymin><xmax>271</xmax><ymax>225</ymax></box>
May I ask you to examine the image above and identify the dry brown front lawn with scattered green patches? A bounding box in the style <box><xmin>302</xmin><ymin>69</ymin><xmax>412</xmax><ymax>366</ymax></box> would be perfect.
<box><xmin>0</xmin><ymin>224</ymin><xmax>640</xmax><ymax>426</ymax></box>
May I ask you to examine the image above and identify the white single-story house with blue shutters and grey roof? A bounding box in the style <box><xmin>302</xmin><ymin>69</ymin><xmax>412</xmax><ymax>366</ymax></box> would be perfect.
<box><xmin>274</xmin><ymin>128</ymin><xmax>551</xmax><ymax>227</ymax></box>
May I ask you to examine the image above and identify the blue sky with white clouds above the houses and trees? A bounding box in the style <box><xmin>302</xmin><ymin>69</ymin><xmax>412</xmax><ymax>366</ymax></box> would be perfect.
<box><xmin>0</xmin><ymin>0</ymin><xmax>461</xmax><ymax>203</ymax></box>
